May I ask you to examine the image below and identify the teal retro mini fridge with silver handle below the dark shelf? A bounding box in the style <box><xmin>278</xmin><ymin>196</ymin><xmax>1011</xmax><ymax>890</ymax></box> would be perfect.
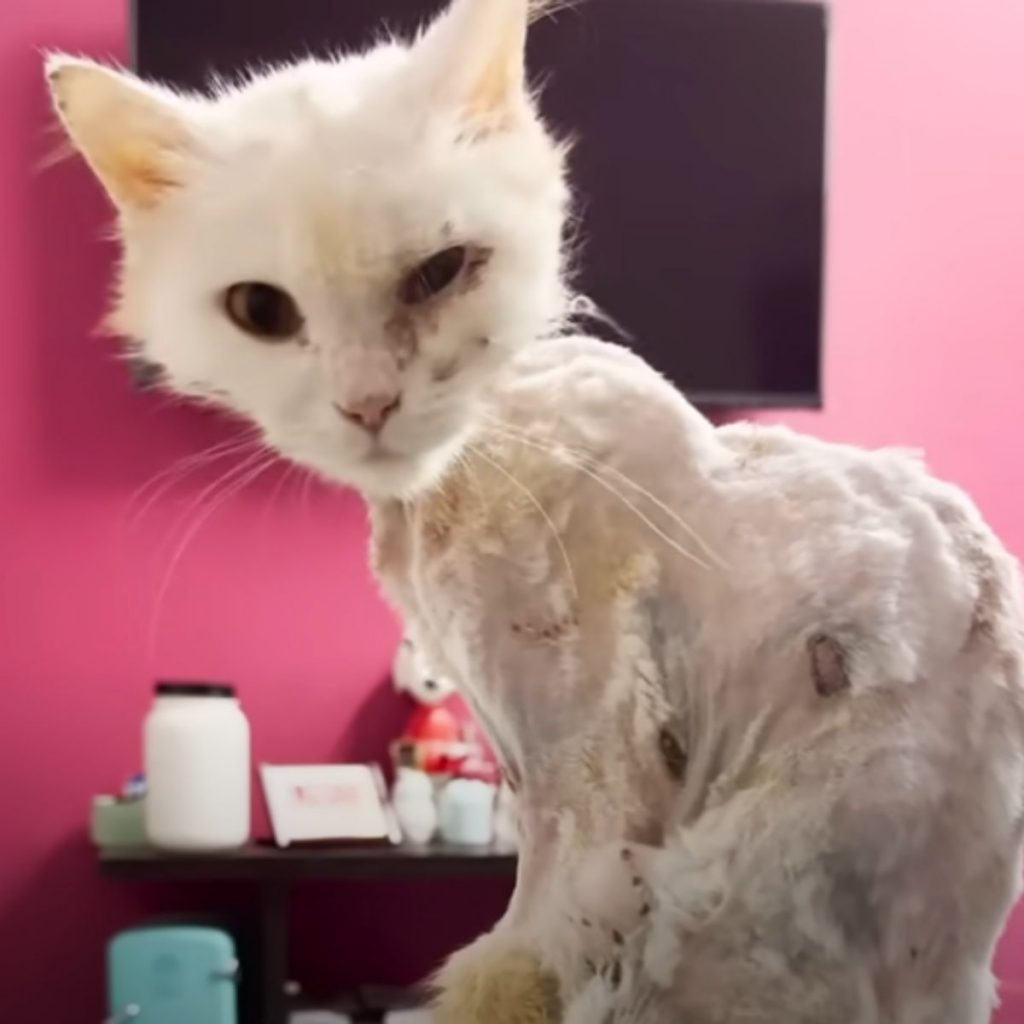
<box><xmin>108</xmin><ymin>927</ymin><xmax>239</xmax><ymax>1024</ymax></box>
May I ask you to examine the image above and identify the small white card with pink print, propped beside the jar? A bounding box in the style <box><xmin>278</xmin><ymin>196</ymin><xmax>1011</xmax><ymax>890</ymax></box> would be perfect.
<box><xmin>260</xmin><ymin>765</ymin><xmax>398</xmax><ymax>847</ymax></box>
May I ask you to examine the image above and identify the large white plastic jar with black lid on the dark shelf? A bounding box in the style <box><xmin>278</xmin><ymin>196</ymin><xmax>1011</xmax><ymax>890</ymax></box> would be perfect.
<box><xmin>143</xmin><ymin>683</ymin><xmax>251</xmax><ymax>852</ymax></box>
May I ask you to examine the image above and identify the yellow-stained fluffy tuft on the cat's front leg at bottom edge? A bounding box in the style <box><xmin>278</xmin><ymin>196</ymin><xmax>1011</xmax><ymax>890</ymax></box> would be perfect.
<box><xmin>434</xmin><ymin>936</ymin><xmax>562</xmax><ymax>1024</ymax></box>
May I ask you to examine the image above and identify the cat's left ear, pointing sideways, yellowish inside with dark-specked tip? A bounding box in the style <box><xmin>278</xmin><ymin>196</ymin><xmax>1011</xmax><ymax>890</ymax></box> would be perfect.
<box><xmin>46</xmin><ymin>54</ymin><xmax>193</xmax><ymax>211</ymax></box>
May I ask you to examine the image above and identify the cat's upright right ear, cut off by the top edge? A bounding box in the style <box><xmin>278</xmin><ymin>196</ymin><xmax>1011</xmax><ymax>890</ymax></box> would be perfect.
<box><xmin>419</xmin><ymin>0</ymin><xmax>538</xmax><ymax>129</ymax></box>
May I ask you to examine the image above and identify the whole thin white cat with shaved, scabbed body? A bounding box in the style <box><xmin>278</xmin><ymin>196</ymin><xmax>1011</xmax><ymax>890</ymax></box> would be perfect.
<box><xmin>49</xmin><ymin>0</ymin><xmax>1024</xmax><ymax>1024</ymax></box>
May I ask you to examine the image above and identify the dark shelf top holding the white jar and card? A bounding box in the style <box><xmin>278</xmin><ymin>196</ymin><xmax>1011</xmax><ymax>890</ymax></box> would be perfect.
<box><xmin>99</xmin><ymin>845</ymin><xmax>516</xmax><ymax>883</ymax></box>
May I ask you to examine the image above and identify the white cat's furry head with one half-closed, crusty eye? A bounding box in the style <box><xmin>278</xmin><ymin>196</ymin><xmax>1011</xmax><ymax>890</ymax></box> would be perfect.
<box><xmin>47</xmin><ymin>0</ymin><xmax>567</xmax><ymax>497</ymax></box>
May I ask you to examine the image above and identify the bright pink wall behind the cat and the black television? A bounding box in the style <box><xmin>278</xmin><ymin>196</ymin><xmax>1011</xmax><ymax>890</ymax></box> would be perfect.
<box><xmin>0</xmin><ymin>0</ymin><xmax>1024</xmax><ymax>1024</ymax></box>
